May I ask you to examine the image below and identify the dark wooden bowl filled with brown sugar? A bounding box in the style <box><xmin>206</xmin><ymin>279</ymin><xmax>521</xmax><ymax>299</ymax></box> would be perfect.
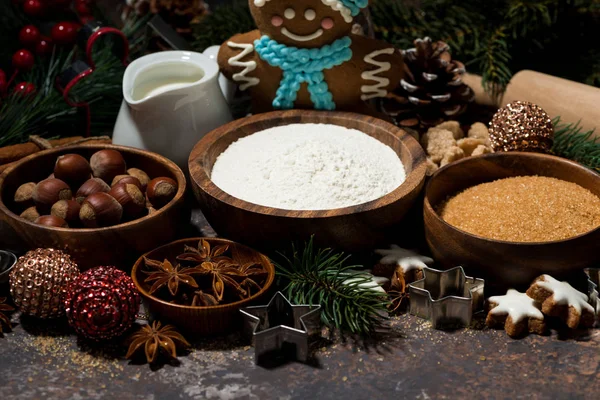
<box><xmin>424</xmin><ymin>152</ymin><xmax>600</xmax><ymax>290</ymax></box>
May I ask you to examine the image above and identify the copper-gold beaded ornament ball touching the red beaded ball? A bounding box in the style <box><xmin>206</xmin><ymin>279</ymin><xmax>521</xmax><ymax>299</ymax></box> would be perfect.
<box><xmin>10</xmin><ymin>249</ymin><xmax>79</xmax><ymax>318</ymax></box>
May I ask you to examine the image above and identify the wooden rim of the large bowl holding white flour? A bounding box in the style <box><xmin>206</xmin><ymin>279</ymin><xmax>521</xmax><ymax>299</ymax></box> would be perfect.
<box><xmin>188</xmin><ymin>110</ymin><xmax>427</xmax><ymax>219</ymax></box>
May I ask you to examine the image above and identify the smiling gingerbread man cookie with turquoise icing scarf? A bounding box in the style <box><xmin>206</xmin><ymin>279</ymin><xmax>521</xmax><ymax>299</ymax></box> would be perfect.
<box><xmin>218</xmin><ymin>0</ymin><xmax>403</xmax><ymax>113</ymax></box>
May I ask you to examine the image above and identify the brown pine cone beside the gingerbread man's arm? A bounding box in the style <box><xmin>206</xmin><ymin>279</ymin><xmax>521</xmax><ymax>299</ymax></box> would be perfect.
<box><xmin>381</xmin><ymin>37</ymin><xmax>475</xmax><ymax>132</ymax></box>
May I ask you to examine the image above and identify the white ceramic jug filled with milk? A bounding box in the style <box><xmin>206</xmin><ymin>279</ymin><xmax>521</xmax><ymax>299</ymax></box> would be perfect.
<box><xmin>113</xmin><ymin>51</ymin><xmax>232</xmax><ymax>171</ymax></box>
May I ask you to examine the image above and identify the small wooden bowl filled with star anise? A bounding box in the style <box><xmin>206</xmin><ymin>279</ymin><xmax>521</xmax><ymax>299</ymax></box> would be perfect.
<box><xmin>131</xmin><ymin>238</ymin><xmax>275</xmax><ymax>335</ymax></box>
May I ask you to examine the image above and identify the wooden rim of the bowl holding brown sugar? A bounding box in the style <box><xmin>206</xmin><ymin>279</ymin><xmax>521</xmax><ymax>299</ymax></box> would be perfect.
<box><xmin>423</xmin><ymin>151</ymin><xmax>600</xmax><ymax>247</ymax></box>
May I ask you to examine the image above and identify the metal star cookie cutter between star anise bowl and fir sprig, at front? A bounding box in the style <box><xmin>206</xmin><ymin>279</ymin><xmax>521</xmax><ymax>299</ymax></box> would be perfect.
<box><xmin>240</xmin><ymin>292</ymin><xmax>321</xmax><ymax>364</ymax></box>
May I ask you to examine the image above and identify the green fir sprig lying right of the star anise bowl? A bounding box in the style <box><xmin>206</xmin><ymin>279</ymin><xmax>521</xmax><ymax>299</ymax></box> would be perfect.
<box><xmin>275</xmin><ymin>238</ymin><xmax>389</xmax><ymax>336</ymax></box>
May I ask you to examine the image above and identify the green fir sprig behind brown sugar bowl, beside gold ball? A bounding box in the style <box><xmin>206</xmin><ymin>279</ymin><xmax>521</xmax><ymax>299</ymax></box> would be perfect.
<box><xmin>552</xmin><ymin>117</ymin><xmax>600</xmax><ymax>172</ymax></box>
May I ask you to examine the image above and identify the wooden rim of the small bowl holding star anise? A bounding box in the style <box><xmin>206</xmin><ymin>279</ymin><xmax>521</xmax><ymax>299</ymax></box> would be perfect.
<box><xmin>131</xmin><ymin>237</ymin><xmax>275</xmax><ymax>310</ymax></box>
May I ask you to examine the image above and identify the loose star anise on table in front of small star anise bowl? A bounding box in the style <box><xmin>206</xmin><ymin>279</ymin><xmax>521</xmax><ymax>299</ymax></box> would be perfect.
<box><xmin>125</xmin><ymin>321</ymin><xmax>190</xmax><ymax>364</ymax></box>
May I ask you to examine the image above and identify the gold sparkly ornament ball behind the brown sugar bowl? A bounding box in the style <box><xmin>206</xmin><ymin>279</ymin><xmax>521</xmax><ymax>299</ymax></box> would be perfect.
<box><xmin>490</xmin><ymin>101</ymin><xmax>554</xmax><ymax>153</ymax></box>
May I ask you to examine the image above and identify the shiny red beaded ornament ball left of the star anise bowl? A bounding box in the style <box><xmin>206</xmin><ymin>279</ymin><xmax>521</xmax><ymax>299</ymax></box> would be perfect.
<box><xmin>64</xmin><ymin>267</ymin><xmax>140</xmax><ymax>340</ymax></box>
